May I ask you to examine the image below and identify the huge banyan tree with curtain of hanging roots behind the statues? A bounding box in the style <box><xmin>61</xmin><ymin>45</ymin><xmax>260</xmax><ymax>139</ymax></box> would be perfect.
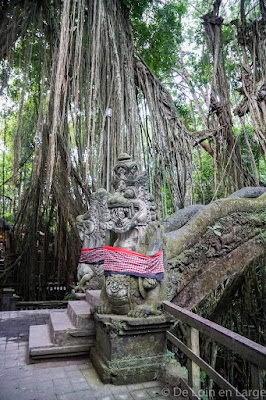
<box><xmin>0</xmin><ymin>0</ymin><xmax>192</xmax><ymax>298</ymax></box>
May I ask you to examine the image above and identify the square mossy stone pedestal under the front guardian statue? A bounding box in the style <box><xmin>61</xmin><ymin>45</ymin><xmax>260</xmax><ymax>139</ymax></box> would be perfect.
<box><xmin>90</xmin><ymin>314</ymin><xmax>174</xmax><ymax>385</ymax></box>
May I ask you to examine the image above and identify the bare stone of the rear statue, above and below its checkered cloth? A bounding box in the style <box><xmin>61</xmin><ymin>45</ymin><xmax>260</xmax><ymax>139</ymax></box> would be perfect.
<box><xmin>73</xmin><ymin>189</ymin><xmax>111</xmax><ymax>293</ymax></box>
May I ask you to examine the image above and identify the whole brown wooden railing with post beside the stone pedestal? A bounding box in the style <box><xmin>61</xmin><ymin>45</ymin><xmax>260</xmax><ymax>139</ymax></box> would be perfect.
<box><xmin>163</xmin><ymin>301</ymin><xmax>266</xmax><ymax>400</ymax></box>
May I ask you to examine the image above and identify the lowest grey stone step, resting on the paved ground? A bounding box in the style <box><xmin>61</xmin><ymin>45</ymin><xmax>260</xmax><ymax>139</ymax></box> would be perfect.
<box><xmin>29</xmin><ymin>324</ymin><xmax>91</xmax><ymax>363</ymax></box>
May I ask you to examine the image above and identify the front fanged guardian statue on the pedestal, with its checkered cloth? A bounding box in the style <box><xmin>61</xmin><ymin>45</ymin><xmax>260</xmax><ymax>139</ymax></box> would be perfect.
<box><xmin>97</xmin><ymin>154</ymin><xmax>164</xmax><ymax>317</ymax></box>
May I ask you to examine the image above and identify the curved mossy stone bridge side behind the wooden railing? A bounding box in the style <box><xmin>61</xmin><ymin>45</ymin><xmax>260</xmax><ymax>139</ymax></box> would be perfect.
<box><xmin>164</xmin><ymin>188</ymin><xmax>266</xmax><ymax>310</ymax></box>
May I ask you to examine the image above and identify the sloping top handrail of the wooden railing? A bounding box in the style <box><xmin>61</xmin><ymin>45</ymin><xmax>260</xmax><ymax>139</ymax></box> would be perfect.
<box><xmin>163</xmin><ymin>301</ymin><xmax>266</xmax><ymax>369</ymax></box>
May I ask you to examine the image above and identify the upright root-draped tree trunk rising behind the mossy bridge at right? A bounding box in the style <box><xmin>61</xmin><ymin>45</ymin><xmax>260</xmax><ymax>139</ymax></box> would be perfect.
<box><xmin>202</xmin><ymin>0</ymin><xmax>255</xmax><ymax>192</ymax></box>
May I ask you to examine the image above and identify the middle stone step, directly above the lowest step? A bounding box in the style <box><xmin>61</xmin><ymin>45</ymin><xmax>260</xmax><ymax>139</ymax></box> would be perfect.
<box><xmin>49</xmin><ymin>310</ymin><xmax>95</xmax><ymax>346</ymax></box>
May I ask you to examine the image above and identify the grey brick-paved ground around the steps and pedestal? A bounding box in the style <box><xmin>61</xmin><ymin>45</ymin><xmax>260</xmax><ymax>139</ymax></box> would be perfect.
<box><xmin>0</xmin><ymin>310</ymin><xmax>174</xmax><ymax>400</ymax></box>
